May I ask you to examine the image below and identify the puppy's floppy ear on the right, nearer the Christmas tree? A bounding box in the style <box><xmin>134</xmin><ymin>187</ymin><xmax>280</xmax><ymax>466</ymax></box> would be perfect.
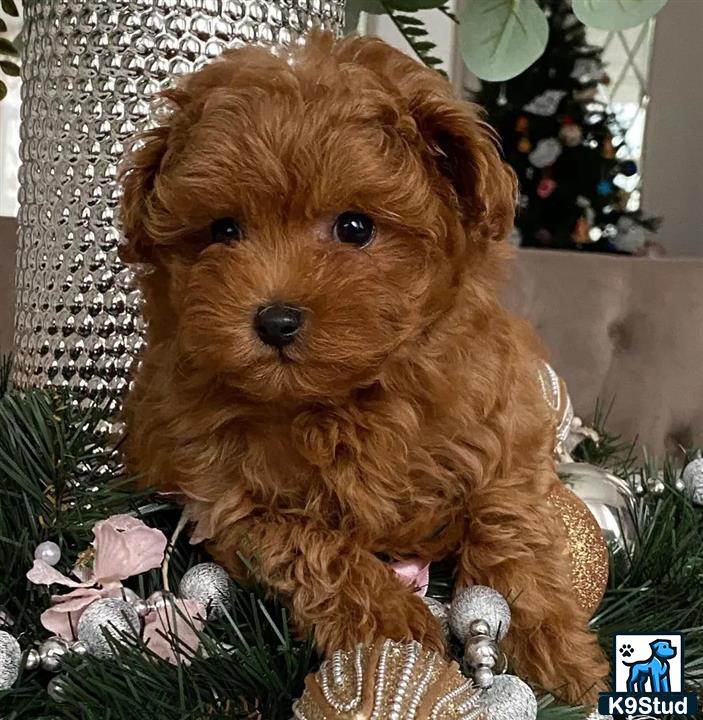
<box><xmin>410</xmin><ymin>90</ymin><xmax>517</xmax><ymax>240</ymax></box>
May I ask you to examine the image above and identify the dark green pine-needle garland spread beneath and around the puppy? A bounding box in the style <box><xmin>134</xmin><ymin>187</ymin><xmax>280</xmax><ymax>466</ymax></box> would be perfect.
<box><xmin>0</xmin><ymin>360</ymin><xmax>703</xmax><ymax>720</ymax></box>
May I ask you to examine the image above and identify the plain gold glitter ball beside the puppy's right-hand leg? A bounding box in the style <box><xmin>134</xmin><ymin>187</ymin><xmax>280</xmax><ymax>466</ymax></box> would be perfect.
<box><xmin>549</xmin><ymin>485</ymin><xmax>608</xmax><ymax>615</ymax></box>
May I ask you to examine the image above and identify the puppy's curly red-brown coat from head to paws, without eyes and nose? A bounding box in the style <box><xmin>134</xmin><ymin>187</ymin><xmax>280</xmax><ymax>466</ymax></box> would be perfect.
<box><xmin>122</xmin><ymin>34</ymin><xmax>606</xmax><ymax>700</ymax></box>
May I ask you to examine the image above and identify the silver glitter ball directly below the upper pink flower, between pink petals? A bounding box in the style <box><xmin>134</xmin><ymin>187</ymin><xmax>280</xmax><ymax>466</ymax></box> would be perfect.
<box><xmin>77</xmin><ymin>598</ymin><xmax>141</xmax><ymax>657</ymax></box>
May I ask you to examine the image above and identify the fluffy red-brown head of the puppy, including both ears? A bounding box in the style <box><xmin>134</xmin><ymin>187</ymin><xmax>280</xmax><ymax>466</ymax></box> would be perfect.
<box><xmin>122</xmin><ymin>34</ymin><xmax>515</xmax><ymax>402</ymax></box>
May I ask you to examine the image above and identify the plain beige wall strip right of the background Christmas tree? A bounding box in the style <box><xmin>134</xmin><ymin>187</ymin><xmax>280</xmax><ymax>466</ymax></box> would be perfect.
<box><xmin>642</xmin><ymin>0</ymin><xmax>703</xmax><ymax>256</ymax></box>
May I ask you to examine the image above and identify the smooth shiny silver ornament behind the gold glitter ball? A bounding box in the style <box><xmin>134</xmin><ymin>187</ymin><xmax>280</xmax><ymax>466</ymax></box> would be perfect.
<box><xmin>557</xmin><ymin>463</ymin><xmax>637</xmax><ymax>578</ymax></box>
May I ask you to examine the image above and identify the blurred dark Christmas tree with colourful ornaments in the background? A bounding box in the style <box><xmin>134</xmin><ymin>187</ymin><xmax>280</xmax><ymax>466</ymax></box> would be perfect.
<box><xmin>477</xmin><ymin>0</ymin><xmax>657</xmax><ymax>253</ymax></box>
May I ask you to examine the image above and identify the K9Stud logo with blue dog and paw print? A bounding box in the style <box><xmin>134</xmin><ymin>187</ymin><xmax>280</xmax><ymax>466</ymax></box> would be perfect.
<box><xmin>598</xmin><ymin>632</ymin><xmax>697</xmax><ymax>718</ymax></box>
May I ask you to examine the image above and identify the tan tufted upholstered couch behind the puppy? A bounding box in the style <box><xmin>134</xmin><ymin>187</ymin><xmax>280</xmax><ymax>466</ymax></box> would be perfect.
<box><xmin>0</xmin><ymin>218</ymin><xmax>703</xmax><ymax>454</ymax></box>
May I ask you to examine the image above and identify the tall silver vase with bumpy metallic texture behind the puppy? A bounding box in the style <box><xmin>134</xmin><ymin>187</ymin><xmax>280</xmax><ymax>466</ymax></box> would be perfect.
<box><xmin>15</xmin><ymin>0</ymin><xmax>344</xmax><ymax>397</ymax></box>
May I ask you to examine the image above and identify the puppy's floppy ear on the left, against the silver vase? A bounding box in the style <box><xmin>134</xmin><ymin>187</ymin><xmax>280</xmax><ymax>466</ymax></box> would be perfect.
<box><xmin>118</xmin><ymin>126</ymin><xmax>169</xmax><ymax>263</ymax></box>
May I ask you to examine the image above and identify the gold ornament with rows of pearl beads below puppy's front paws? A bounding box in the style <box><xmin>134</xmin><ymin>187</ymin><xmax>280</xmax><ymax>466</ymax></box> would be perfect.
<box><xmin>293</xmin><ymin>640</ymin><xmax>482</xmax><ymax>720</ymax></box>
